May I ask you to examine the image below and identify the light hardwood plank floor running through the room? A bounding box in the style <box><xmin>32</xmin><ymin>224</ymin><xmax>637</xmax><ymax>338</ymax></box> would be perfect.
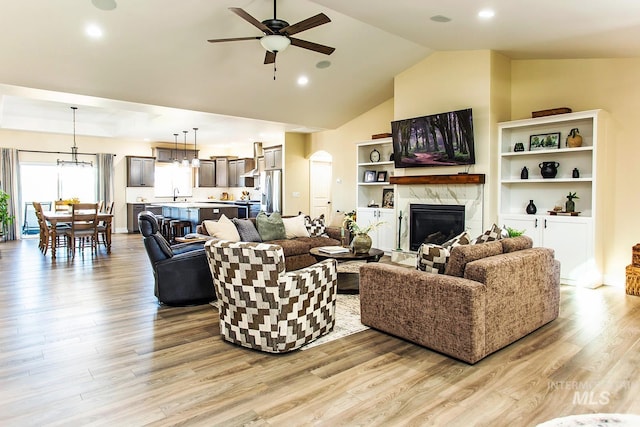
<box><xmin>0</xmin><ymin>234</ymin><xmax>640</xmax><ymax>426</ymax></box>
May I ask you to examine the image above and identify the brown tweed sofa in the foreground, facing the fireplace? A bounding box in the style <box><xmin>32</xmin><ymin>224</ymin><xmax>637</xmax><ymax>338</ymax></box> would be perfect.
<box><xmin>360</xmin><ymin>236</ymin><xmax>560</xmax><ymax>364</ymax></box>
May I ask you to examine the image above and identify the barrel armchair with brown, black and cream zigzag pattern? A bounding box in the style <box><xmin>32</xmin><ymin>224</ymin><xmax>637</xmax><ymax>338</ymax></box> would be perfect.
<box><xmin>205</xmin><ymin>240</ymin><xmax>337</xmax><ymax>353</ymax></box>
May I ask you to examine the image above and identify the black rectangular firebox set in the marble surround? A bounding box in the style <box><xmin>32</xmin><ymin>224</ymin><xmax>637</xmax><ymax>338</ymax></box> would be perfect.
<box><xmin>409</xmin><ymin>204</ymin><xmax>465</xmax><ymax>251</ymax></box>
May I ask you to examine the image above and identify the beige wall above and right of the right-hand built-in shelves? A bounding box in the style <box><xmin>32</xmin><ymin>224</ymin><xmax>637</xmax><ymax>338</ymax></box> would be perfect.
<box><xmin>511</xmin><ymin>58</ymin><xmax>640</xmax><ymax>286</ymax></box>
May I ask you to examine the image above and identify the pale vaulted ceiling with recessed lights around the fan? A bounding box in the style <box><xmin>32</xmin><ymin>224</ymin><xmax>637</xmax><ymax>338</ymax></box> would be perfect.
<box><xmin>0</xmin><ymin>0</ymin><xmax>640</xmax><ymax>143</ymax></box>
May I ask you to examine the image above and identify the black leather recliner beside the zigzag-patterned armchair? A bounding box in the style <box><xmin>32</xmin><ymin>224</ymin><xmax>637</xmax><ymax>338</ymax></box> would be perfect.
<box><xmin>138</xmin><ymin>211</ymin><xmax>216</xmax><ymax>305</ymax></box>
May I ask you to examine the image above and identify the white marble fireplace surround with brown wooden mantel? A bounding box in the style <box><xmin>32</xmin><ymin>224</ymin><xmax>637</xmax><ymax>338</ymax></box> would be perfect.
<box><xmin>391</xmin><ymin>174</ymin><xmax>485</xmax><ymax>263</ymax></box>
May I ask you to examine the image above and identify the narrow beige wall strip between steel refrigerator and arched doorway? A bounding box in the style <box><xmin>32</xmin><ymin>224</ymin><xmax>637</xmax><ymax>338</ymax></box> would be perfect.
<box><xmin>282</xmin><ymin>133</ymin><xmax>309</xmax><ymax>215</ymax></box>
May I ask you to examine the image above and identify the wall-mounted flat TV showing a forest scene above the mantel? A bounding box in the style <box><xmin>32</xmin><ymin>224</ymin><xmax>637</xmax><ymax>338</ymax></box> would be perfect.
<box><xmin>391</xmin><ymin>108</ymin><xmax>476</xmax><ymax>168</ymax></box>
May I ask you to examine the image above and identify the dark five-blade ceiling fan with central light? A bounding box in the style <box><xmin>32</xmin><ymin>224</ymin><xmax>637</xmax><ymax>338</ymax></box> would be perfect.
<box><xmin>207</xmin><ymin>0</ymin><xmax>335</xmax><ymax>66</ymax></box>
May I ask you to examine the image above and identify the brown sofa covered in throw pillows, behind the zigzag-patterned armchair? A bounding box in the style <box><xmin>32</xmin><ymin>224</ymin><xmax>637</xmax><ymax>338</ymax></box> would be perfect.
<box><xmin>196</xmin><ymin>218</ymin><xmax>341</xmax><ymax>271</ymax></box>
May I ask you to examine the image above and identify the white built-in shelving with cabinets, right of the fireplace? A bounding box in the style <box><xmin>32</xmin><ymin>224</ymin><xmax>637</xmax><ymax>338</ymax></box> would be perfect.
<box><xmin>498</xmin><ymin>110</ymin><xmax>607</xmax><ymax>287</ymax></box>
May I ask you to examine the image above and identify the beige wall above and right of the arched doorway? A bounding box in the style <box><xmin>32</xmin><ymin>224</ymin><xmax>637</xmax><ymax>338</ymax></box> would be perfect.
<box><xmin>307</xmin><ymin>99</ymin><xmax>393</xmax><ymax>221</ymax></box>
